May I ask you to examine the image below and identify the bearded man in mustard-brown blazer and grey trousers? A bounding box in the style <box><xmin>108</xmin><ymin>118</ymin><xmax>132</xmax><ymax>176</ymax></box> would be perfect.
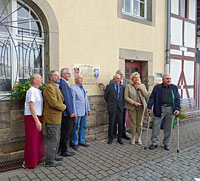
<box><xmin>43</xmin><ymin>70</ymin><xmax>66</xmax><ymax>167</ymax></box>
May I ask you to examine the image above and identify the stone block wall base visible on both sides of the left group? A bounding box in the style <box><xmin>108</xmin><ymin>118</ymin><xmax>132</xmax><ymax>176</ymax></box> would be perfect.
<box><xmin>0</xmin><ymin>96</ymin><xmax>108</xmax><ymax>161</ymax></box>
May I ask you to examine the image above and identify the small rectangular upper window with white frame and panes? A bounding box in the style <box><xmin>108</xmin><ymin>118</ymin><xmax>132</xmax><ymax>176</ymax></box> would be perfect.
<box><xmin>122</xmin><ymin>0</ymin><xmax>147</xmax><ymax>18</ymax></box>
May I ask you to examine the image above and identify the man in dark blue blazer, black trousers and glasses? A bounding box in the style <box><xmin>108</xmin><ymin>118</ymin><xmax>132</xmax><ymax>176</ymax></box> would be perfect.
<box><xmin>59</xmin><ymin>68</ymin><xmax>77</xmax><ymax>157</ymax></box>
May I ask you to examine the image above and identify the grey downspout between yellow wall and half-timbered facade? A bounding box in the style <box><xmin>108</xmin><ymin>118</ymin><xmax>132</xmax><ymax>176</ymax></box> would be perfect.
<box><xmin>165</xmin><ymin>0</ymin><xmax>171</xmax><ymax>74</ymax></box>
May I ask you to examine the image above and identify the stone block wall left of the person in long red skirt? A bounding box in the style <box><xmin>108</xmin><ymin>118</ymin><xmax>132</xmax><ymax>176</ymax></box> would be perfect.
<box><xmin>0</xmin><ymin>101</ymin><xmax>24</xmax><ymax>161</ymax></box>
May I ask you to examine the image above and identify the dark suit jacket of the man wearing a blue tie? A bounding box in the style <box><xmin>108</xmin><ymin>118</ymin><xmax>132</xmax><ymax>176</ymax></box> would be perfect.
<box><xmin>104</xmin><ymin>83</ymin><xmax>124</xmax><ymax>112</ymax></box>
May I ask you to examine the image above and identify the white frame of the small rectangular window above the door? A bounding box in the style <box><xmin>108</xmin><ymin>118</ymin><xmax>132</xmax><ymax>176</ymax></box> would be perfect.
<box><xmin>122</xmin><ymin>0</ymin><xmax>147</xmax><ymax>19</ymax></box>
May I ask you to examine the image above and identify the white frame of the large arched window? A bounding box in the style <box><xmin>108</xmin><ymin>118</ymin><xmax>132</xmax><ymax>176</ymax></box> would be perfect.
<box><xmin>0</xmin><ymin>0</ymin><xmax>45</xmax><ymax>100</ymax></box>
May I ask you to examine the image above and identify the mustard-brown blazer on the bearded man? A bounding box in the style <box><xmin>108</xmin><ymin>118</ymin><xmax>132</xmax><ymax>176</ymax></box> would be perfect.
<box><xmin>42</xmin><ymin>82</ymin><xmax>66</xmax><ymax>124</ymax></box>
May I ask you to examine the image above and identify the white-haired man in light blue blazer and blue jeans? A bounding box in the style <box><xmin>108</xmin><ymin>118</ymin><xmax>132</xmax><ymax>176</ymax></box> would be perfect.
<box><xmin>71</xmin><ymin>75</ymin><xmax>90</xmax><ymax>150</ymax></box>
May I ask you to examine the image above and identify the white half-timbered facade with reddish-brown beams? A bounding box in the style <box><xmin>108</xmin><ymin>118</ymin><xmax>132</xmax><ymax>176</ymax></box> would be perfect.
<box><xmin>169</xmin><ymin>0</ymin><xmax>197</xmax><ymax>99</ymax></box>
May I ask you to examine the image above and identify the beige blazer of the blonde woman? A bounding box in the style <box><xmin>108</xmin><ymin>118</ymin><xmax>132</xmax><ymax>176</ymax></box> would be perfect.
<box><xmin>124</xmin><ymin>81</ymin><xmax>149</xmax><ymax>110</ymax></box>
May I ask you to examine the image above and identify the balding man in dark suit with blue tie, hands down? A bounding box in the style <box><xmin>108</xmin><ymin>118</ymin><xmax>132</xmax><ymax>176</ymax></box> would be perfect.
<box><xmin>104</xmin><ymin>74</ymin><xmax>124</xmax><ymax>144</ymax></box>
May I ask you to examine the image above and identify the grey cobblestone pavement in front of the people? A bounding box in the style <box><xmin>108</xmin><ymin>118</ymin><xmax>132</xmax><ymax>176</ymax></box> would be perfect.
<box><xmin>0</xmin><ymin>118</ymin><xmax>200</xmax><ymax>181</ymax></box>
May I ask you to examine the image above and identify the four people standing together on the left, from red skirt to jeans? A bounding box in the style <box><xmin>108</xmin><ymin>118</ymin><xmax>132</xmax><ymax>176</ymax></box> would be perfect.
<box><xmin>22</xmin><ymin>68</ymin><xmax>90</xmax><ymax>169</ymax></box>
